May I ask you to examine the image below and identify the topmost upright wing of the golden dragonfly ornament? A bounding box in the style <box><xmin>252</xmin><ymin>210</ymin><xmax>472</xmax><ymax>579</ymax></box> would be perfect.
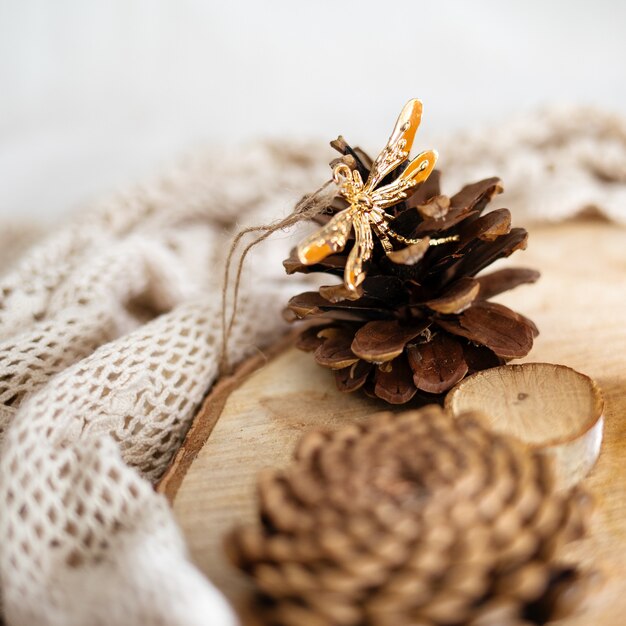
<box><xmin>365</xmin><ymin>98</ymin><xmax>422</xmax><ymax>191</ymax></box>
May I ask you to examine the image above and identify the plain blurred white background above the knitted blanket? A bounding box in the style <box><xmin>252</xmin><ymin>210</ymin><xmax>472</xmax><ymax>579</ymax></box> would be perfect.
<box><xmin>0</xmin><ymin>0</ymin><xmax>626</xmax><ymax>219</ymax></box>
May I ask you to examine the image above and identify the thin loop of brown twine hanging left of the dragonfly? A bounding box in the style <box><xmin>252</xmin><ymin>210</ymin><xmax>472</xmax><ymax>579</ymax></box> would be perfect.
<box><xmin>219</xmin><ymin>180</ymin><xmax>333</xmax><ymax>375</ymax></box>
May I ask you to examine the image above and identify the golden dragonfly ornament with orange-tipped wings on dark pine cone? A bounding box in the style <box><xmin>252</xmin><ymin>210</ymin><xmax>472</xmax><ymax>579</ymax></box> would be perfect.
<box><xmin>297</xmin><ymin>99</ymin><xmax>456</xmax><ymax>291</ymax></box>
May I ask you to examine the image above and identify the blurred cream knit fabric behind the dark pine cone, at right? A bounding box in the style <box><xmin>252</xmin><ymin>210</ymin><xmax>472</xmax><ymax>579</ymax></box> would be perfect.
<box><xmin>437</xmin><ymin>106</ymin><xmax>626</xmax><ymax>224</ymax></box>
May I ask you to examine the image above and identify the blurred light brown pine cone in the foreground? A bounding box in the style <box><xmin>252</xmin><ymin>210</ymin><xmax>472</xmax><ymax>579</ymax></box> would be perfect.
<box><xmin>226</xmin><ymin>405</ymin><xmax>589</xmax><ymax>626</ymax></box>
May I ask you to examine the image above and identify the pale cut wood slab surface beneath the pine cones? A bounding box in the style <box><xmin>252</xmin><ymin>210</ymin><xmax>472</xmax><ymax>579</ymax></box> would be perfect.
<box><xmin>162</xmin><ymin>220</ymin><xmax>626</xmax><ymax>626</ymax></box>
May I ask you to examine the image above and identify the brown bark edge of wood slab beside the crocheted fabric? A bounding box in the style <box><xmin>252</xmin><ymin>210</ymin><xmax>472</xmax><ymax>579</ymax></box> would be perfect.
<box><xmin>155</xmin><ymin>331</ymin><xmax>298</xmax><ymax>504</ymax></box>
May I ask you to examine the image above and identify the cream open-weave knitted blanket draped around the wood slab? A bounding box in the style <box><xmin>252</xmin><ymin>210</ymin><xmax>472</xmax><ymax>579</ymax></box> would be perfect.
<box><xmin>0</xmin><ymin>112</ymin><xmax>626</xmax><ymax>626</ymax></box>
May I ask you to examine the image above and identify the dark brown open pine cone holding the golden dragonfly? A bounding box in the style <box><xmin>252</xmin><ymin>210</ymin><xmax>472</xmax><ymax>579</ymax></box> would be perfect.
<box><xmin>284</xmin><ymin>147</ymin><xmax>539</xmax><ymax>404</ymax></box>
